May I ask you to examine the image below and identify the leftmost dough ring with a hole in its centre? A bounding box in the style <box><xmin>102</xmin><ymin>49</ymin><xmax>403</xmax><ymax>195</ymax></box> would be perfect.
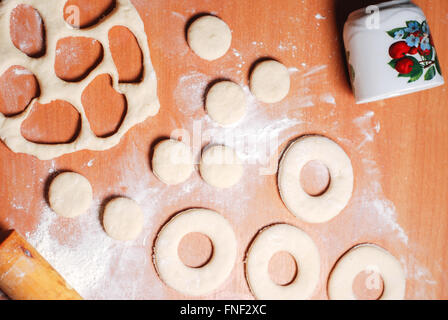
<box><xmin>154</xmin><ymin>209</ymin><xmax>237</xmax><ymax>296</ymax></box>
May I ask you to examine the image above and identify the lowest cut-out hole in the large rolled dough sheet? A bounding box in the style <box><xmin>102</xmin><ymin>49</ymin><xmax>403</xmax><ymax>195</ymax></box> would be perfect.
<box><xmin>20</xmin><ymin>100</ymin><xmax>81</xmax><ymax>144</ymax></box>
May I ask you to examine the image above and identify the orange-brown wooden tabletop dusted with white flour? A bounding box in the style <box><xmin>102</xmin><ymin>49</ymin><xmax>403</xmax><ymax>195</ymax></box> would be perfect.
<box><xmin>0</xmin><ymin>0</ymin><xmax>448</xmax><ymax>299</ymax></box>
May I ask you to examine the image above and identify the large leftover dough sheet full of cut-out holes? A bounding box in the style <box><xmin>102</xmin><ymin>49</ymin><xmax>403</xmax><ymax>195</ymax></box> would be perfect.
<box><xmin>0</xmin><ymin>0</ymin><xmax>160</xmax><ymax>160</ymax></box>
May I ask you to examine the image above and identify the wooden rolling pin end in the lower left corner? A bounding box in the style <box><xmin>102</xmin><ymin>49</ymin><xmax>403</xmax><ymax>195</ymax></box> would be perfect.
<box><xmin>0</xmin><ymin>230</ymin><xmax>82</xmax><ymax>300</ymax></box>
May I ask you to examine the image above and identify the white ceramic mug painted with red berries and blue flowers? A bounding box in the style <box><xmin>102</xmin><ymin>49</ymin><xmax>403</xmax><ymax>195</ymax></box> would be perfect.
<box><xmin>344</xmin><ymin>0</ymin><xmax>444</xmax><ymax>104</ymax></box>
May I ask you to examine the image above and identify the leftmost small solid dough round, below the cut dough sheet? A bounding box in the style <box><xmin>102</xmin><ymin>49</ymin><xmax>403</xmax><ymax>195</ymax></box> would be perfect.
<box><xmin>48</xmin><ymin>172</ymin><xmax>93</xmax><ymax>218</ymax></box>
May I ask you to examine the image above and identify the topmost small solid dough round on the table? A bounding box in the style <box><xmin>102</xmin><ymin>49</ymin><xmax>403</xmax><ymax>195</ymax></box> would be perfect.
<box><xmin>187</xmin><ymin>15</ymin><xmax>232</xmax><ymax>61</ymax></box>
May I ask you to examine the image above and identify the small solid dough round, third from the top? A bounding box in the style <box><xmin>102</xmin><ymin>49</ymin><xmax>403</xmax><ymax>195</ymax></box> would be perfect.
<box><xmin>205</xmin><ymin>81</ymin><xmax>247</xmax><ymax>126</ymax></box>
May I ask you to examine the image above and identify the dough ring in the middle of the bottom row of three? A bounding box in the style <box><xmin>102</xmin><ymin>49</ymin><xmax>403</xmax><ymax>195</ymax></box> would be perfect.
<box><xmin>246</xmin><ymin>224</ymin><xmax>320</xmax><ymax>300</ymax></box>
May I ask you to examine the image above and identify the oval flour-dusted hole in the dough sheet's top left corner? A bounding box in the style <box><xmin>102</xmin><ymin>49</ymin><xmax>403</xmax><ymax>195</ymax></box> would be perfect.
<box><xmin>10</xmin><ymin>4</ymin><xmax>46</xmax><ymax>58</ymax></box>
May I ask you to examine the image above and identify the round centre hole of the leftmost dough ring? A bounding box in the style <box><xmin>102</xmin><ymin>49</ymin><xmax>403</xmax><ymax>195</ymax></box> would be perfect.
<box><xmin>177</xmin><ymin>232</ymin><xmax>213</xmax><ymax>268</ymax></box>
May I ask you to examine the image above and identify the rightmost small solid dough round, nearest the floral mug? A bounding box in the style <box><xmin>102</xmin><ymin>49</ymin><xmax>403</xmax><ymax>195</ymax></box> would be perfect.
<box><xmin>250</xmin><ymin>60</ymin><xmax>291</xmax><ymax>103</ymax></box>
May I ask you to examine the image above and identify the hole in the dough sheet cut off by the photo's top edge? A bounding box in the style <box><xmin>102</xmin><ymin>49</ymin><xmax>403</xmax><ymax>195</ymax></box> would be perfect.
<box><xmin>63</xmin><ymin>0</ymin><xmax>117</xmax><ymax>29</ymax></box>
